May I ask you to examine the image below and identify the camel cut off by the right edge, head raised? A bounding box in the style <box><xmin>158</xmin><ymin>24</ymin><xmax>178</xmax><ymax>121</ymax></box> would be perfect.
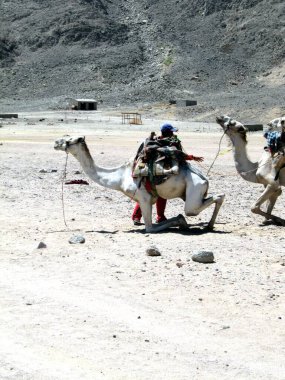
<box><xmin>217</xmin><ymin>115</ymin><xmax>285</xmax><ymax>225</ymax></box>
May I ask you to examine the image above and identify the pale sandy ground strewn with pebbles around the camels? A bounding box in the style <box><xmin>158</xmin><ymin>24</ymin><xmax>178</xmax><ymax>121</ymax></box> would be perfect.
<box><xmin>0</xmin><ymin>112</ymin><xmax>285</xmax><ymax>380</ymax></box>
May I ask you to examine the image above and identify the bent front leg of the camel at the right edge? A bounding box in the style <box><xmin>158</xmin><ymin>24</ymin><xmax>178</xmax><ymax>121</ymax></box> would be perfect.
<box><xmin>251</xmin><ymin>185</ymin><xmax>285</xmax><ymax>226</ymax></box>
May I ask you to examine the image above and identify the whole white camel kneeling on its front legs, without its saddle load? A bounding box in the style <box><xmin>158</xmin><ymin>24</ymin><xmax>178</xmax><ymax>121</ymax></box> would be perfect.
<box><xmin>54</xmin><ymin>136</ymin><xmax>224</xmax><ymax>232</ymax></box>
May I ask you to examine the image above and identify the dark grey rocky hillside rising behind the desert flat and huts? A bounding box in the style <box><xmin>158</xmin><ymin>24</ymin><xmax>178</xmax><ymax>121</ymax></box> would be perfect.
<box><xmin>0</xmin><ymin>0</ymin><xmax>285</xmax><ymax>120</ymax></box>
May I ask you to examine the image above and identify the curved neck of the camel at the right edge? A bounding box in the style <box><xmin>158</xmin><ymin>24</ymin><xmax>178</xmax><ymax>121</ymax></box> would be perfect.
<box><xmin>233</xmin><ymin>137</ymin><xmax>258</xmax><ymax>183</ymax></box>
